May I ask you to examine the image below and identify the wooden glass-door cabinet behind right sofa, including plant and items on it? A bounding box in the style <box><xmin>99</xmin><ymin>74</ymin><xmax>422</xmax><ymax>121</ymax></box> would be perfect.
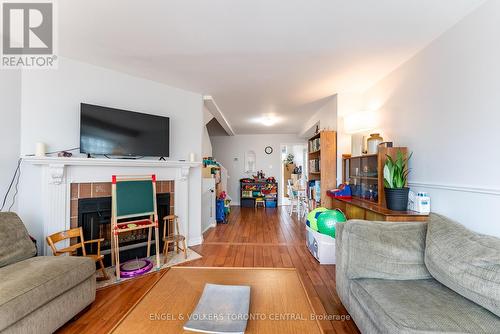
<box><xmin>327</xmin><ymin>134</ymin><xmax>430</xmax><ymax>221</ymax></box>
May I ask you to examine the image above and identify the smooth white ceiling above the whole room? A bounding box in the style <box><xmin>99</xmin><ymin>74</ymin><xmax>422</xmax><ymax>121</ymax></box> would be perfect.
<box><xmin>58</xmin><ymin>0</ymin><xmax>483</xmax><ymax>134</ymax></box>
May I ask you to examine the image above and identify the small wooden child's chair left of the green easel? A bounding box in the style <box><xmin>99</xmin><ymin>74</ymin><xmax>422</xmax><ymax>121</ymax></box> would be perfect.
<box><xmin>47</xmin><ymin>227</ymin><xmax>109</xmax><ymax>281</ymax></box>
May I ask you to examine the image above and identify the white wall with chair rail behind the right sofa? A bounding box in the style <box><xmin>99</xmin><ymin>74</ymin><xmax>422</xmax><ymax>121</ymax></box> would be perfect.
<box><xmin>341</xmin><ymin>0</ymin><xmax>500</xmax><ymax>236</ymax></box>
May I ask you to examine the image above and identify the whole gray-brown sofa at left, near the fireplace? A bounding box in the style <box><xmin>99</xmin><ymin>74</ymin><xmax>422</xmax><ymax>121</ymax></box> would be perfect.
<box><xmin>0</xmin><ymin>212</ymin><xmax>95</xmax><ymax>334</ymax></box>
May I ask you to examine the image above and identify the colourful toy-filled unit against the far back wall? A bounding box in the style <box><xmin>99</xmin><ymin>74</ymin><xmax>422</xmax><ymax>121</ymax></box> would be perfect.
<box><xmin>240</xmin><ymin>171</ymin><xmax>278</xmax><ymax>208</ymax></box>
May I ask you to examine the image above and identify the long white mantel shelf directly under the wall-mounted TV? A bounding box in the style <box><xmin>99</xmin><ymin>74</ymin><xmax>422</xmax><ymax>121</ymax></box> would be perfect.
<box><xmin>21</xmin><ymin>156</ymin><xmax>202</xmax><ymax>168</ymax></box>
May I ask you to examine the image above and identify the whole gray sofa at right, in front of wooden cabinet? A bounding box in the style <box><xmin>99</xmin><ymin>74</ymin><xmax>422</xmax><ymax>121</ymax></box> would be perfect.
<box><xmin>336</xmin><ymin>214</ymin><xmax>500</xmax><ymax>334</ymax></box>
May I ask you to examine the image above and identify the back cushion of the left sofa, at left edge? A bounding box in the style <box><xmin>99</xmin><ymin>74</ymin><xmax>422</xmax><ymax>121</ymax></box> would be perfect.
<box><xmin>0</xmin><ymin>212</ymin><xmax>36</xmax><ymax>268</ymax></box>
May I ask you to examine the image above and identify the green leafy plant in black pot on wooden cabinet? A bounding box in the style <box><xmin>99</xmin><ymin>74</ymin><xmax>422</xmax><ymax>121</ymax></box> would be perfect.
<box><xmin>384</xmin><ymin>151</ymin><xmax>413</xmax><ymax>211</ymax></box>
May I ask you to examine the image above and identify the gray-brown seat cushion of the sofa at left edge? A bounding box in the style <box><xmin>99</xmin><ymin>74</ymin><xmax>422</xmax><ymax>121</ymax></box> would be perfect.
<box><xmin>0</xmin><ymin>256</ymin><xmax>95</xmax><ymax>331</ymax></box>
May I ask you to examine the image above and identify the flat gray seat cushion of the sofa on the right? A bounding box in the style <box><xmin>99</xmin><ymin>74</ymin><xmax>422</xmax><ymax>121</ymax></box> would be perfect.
<box><xmin>351</xmin><ymin>279</ymin><xmax>500</xmax><ymax>333</ymax></box>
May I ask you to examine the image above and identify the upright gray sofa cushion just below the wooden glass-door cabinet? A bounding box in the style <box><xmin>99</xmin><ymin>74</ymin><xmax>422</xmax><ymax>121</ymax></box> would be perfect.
<box><xmin>343</xmin><ymin>220</ymin><xmax>431</xmax><ymax>280</ymax></box>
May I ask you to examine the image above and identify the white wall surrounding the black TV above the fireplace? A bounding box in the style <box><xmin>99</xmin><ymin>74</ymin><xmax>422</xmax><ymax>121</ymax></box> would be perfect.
<box><xmin>21</xmin><ymin>58</ymin><xmax>204</xmax><ymax>243</ymax></box>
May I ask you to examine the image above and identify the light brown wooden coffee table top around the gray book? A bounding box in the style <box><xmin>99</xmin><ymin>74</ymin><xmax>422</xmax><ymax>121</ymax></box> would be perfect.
<box><xmin>111</xmin><ymin>267</ymin><xmax>323</xmax><ymax>334</ymax></box>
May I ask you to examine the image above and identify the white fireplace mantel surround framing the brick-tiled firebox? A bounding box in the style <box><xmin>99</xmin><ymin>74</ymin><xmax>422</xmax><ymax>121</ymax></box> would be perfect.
<box><xmin>19</xmin><ymin>156</ymin><xmax>202</xmax><ymax>254</ymax></box>
